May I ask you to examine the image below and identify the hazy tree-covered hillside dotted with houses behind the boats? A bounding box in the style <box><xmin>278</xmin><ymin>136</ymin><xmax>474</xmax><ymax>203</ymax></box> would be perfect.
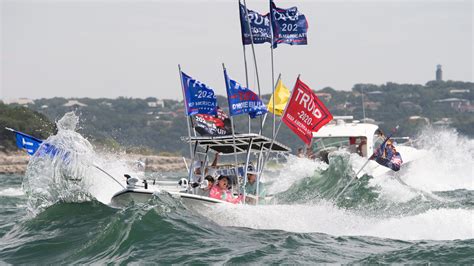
<box><xmin>0</xmin><ymin>81</ymin><xmax>474</xmax><ymax>155</ymax></box>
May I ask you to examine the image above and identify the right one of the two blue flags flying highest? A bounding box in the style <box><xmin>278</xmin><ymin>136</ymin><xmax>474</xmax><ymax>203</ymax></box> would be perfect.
<box><xmin>270</xmin><ymin>0</ymin><xmax>308</xmax><ymax>47</ymax></box>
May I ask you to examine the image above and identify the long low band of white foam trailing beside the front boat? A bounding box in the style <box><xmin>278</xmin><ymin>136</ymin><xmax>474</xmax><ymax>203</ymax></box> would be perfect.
<box><xmin>205</xmin><ymin>203</ymin><xmax>474</xmax><ymax>240</ymax></box>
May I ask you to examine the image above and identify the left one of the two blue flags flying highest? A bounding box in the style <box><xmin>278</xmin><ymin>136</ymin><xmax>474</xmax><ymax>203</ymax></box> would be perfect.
<box><xmin>239</xmin><ymin>2</ymin><xmax>272</xmax><ymax>45</ymax></box>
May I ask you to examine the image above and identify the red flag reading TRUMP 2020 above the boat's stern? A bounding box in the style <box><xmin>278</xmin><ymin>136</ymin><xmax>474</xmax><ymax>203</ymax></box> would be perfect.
<box><xmin>282</xmin><ymin>78</ymin><xmax>332</xmax><ymax>144</ymax></box>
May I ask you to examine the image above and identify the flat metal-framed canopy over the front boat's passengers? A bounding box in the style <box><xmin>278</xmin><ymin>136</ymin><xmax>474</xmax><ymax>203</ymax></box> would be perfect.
<box><xmin>182</xmin><ymin>133</ymin><xmax>291</xmax><ymax>154</ymax></box>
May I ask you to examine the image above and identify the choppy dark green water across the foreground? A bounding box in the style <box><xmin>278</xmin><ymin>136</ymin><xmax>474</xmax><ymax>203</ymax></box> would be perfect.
<box><xmin>0</xmin><ymin>172</ymin><xmax>474</xmax><ymax>264</ymax></box>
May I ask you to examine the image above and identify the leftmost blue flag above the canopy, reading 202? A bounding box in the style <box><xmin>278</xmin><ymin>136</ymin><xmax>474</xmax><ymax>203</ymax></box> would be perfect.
<box><xmin>181</xmin><ymin>72</ymin><xmax>217</xmax><ymax>116</ymax></box>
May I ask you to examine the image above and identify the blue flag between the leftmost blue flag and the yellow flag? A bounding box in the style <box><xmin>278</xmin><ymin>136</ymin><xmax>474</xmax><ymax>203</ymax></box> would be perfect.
<box><xmin>224</xmin><ymin>70</ymin><xmax>267</xmax><ymax>118</ymax></box>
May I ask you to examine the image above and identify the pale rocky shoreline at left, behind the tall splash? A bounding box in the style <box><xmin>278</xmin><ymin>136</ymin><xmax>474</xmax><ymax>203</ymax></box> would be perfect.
<box><xmin>0</xmin><ymin>151</ymin><xmax>186</xmax><ymax>174</ymax></box>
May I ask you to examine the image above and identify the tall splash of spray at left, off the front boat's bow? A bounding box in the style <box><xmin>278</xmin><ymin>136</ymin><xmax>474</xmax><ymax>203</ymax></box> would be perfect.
<box><xmin>23</xmin><ymin>112</ymin><xmax>128</xmax><ymax>214</ymax></box>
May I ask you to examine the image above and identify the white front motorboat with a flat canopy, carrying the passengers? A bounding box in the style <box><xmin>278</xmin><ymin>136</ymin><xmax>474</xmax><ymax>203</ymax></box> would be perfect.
<box><xmin>111</xmin><ymin>133</ymin><xmax>291</xmax><ymax>207</ymax></box>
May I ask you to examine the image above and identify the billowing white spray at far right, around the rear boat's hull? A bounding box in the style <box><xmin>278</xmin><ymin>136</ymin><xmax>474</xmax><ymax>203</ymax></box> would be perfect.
<box><xmin>342</xmin><ymin>128</ymin><xmax>474</xmax><ymax>202</ymax></box>
